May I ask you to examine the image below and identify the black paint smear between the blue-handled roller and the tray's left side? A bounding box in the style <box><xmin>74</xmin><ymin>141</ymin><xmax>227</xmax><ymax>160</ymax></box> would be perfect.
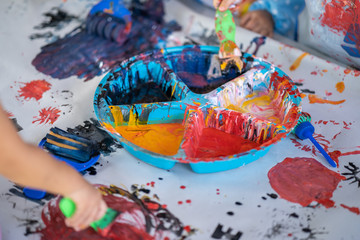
<box><xmin>67</xmin><ymin>118</ymin><xmax>122</xmax><ymax>156</ymax></box>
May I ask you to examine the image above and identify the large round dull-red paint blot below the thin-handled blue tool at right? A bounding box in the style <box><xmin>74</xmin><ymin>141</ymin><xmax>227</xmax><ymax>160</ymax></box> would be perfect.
<box><xmin>268</xmin><ymin>158</ymin><xmax>346</xmax><ymax>208</ymax></box>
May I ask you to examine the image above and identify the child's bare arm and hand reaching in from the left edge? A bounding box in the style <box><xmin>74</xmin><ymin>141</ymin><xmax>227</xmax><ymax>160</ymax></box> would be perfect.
<box><xmin>0</xmin><ymin>106</ymin><xmax>107</xmax><ymax>230</ymax></box>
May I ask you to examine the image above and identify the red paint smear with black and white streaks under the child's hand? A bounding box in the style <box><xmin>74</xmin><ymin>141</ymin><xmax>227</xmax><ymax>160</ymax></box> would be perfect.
<box><xmin>38</xmin><ymin>185</ymin><xmax>193</xmax><ymax>240</ymax></box>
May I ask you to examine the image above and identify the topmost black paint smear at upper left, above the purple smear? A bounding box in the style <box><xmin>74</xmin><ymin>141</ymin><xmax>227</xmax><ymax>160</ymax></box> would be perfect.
<box><xmin>34</xmin><ymin>7</ymin><xmax>78</xmax><ymax>30</ymax></box>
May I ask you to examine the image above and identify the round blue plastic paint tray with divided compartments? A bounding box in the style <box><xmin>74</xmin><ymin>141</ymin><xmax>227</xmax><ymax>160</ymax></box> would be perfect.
<box><xmin>94</xmin><ymin>46</ymin><xmax>301</xmax><ymax>173</ymax></box>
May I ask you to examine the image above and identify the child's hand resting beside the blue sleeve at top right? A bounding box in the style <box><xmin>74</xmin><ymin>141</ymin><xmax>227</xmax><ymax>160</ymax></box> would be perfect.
<box><xmin>240</xmin><ymin>10</ymin><xmax>274</xmax><ymax>37</ymax></box>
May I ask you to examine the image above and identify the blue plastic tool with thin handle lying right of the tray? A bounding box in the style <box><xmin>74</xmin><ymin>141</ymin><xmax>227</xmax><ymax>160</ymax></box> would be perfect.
<box><xmin>295</xmin><ymin>121</ymin><xmax>337</xmax><ymax>167</ymax></box>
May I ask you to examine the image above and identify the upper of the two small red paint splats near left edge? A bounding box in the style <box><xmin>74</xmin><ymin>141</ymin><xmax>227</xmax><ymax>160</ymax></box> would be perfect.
<box><xmin>19</xmin><ymin>80</ymin><xmax>51</xmax><ymax>100</ymax></box>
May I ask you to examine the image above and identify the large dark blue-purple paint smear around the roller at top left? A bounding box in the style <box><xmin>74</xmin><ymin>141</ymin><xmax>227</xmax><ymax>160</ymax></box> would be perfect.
<box><xmin>32</xmin><ymin>0</ymin><xmax>180</xmax><ymax>80</ymax></box>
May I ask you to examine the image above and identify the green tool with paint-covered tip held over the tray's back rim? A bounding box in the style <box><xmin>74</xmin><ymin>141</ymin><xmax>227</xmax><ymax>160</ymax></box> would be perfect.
<box><xmin>215</xmin><ymin>9</ymin><xmax>243</xmax><ymax>75</ymax></box>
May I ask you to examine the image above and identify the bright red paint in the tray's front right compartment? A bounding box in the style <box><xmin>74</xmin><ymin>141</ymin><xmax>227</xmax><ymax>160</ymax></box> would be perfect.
<box><xmin>181</xmin><ymin>107</ymin><xmax>292</xmax><ymax>162</ymax></box>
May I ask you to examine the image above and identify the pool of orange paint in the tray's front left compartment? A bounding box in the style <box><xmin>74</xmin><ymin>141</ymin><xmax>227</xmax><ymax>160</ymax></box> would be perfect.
<box><xmin>115</xmin><ymin>123</ymin><xmax>184</xmax><ymax>156</ymax></box>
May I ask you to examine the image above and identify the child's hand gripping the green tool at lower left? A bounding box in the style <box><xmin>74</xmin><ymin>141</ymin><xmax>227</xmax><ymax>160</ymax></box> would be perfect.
<box><xmin>65</xmin><ymin>184</ymin><xmax>107</xmax><ymax>231</ymax></box>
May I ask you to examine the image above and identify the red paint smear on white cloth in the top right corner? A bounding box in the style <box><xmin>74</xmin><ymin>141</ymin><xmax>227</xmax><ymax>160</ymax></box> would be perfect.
<box><xmin>320</xmin><ymin>0</ymin><xmax>360</xmax><ymax>35</ymax></box>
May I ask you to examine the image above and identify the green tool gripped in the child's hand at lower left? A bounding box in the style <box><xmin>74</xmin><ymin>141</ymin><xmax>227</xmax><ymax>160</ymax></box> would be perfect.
<box><xmin>59</xmin><ymin>198</ymin><xmax>119</xmax><ymax>236</ymax></box>
